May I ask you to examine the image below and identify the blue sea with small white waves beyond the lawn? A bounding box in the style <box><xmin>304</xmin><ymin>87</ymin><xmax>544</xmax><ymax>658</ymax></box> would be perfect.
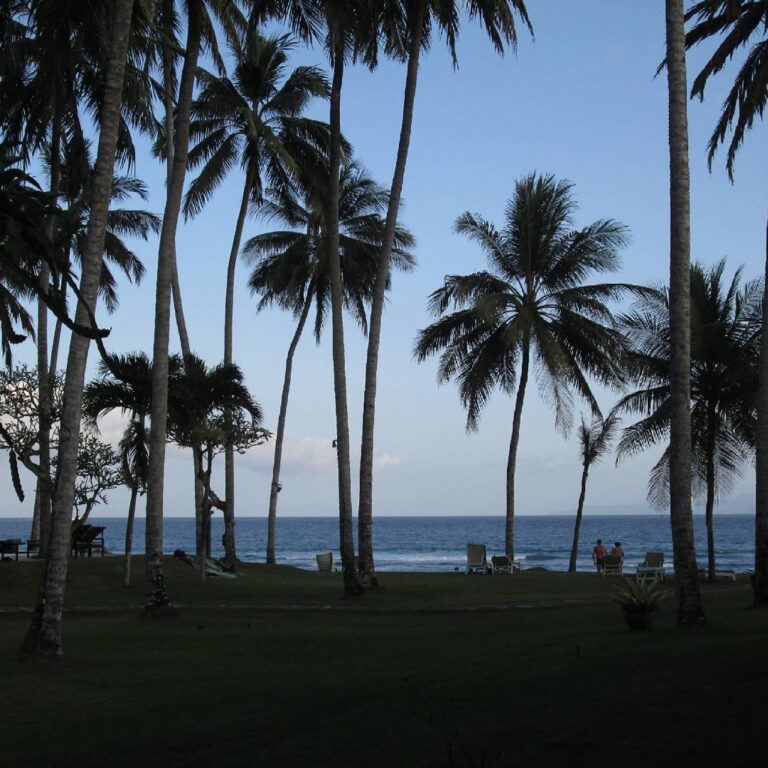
<box><xmin>0</xmin><ymin>514</ymin><xmax>754</xmax><ymax>571</ymax></box>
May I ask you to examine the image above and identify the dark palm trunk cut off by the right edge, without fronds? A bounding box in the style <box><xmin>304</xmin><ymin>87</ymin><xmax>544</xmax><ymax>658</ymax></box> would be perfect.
<box><xmin>752</xmin><ymin>213</ymin><xmax>768</xmax><ymax>605</ymax></box>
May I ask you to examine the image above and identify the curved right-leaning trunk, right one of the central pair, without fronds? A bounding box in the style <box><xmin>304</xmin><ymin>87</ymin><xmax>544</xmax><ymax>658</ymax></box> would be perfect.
<box><xmin>357</xmin><ymin>0</ymin><xmax>426</xmax><ymax>586</ymax></box>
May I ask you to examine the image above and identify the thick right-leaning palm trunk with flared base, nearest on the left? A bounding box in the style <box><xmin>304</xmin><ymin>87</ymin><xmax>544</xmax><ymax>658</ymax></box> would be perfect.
<box><xmin>22</xmin><ymin>0</ymin><xmax>133</xmax><ymax>655</ymax></box>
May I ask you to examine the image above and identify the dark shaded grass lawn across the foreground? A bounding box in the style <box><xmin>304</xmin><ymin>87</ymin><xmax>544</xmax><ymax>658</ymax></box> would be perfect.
<box><xmin>0</xmin><ymin>559</ymin><xmax>768</xmax><ymax>767</ymax></box>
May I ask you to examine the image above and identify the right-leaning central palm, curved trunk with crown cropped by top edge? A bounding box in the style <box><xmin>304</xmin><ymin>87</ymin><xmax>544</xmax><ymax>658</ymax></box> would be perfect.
<box><xmin>358</xmin><ymin>0</ymin><xmax>532</xmax><ymax>586</ymax></box>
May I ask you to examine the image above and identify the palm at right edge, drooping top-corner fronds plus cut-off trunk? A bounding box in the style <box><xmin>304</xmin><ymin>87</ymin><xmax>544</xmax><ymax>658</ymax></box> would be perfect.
<box><xmin>685</xmin><ymin>0</ymin><xmax>768</xmax><ymax>605</ymax></box>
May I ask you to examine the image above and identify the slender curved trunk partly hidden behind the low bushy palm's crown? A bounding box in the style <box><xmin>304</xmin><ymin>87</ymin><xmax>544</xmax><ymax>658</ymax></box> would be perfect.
<box><xmin>224</xmin><ymin>164</ymin><xmax>255</xmax><ymax>569</ymax></box>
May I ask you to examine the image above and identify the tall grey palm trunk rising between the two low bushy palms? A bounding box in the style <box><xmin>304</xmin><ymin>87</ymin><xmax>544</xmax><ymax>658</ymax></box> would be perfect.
<box><xmin>145</xmin><ymin>0</ymin><xmax>201</xmax><ymax>614</ymax></box>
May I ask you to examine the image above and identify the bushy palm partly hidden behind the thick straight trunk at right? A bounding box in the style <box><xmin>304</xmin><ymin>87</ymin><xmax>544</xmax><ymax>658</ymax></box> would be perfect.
<box><xmin>616</xmin><ymin>261</ymin><xmax>762</xmax><ymax>579</ymax></box>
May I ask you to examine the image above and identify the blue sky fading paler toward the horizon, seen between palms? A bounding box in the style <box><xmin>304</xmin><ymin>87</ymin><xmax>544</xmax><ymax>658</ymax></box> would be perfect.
<box><xmin>0</xmin><ymin>0</ymin><xmax>768</xmax><ymax>517</ymax></box>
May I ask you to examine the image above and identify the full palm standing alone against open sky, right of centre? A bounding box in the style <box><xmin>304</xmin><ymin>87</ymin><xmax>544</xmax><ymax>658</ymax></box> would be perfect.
<box><xmin>415</xmin><ymin>174</ymin><xmax>641</xmax><ymax>557</ymax></box>
